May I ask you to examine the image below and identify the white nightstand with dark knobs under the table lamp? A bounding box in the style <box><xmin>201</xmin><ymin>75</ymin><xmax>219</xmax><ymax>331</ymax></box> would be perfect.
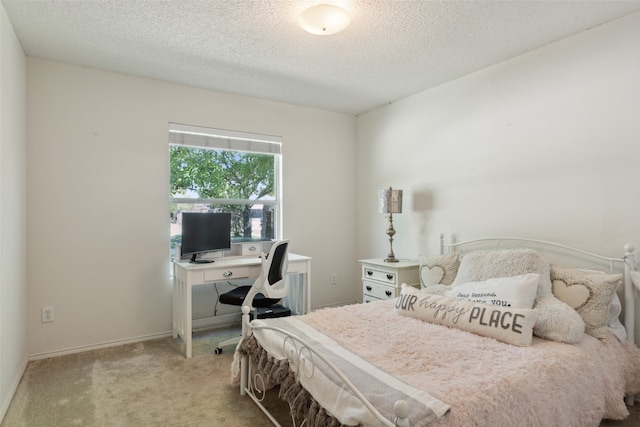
<box><xmin>358</xmin><ymin>258</ymin><xmax>420</xmax><ymax>303</ymax></box>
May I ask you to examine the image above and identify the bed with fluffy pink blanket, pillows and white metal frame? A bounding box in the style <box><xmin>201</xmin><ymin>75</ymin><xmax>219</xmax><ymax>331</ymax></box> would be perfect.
<box><xmin>232</xmin><ymin>237</ymin><xmax>640</xmax><ymax>426</ymax></box>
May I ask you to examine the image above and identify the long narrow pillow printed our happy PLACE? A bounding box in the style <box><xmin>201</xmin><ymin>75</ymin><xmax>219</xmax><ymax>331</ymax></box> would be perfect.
<box><xmin>395</xmin><ymin>284</ymin><xmax>538</xmax><ymax>347</ymax></box>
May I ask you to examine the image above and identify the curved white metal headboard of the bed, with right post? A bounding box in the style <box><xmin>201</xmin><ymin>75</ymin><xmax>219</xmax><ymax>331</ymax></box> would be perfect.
<box><xmin>440</xmin><ymin>234</ymin><xmax>640</xmax><ymax>350</ymax></box>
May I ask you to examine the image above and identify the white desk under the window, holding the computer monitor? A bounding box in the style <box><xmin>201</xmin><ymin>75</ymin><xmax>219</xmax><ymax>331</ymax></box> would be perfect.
<box><xmin>173</xmin><ymin>253</ymin><xmax>311</xmax><ymax>358</ymax></box>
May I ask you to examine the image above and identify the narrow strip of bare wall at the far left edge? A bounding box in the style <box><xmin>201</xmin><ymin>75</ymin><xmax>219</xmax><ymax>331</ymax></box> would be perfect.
<box><xmin>0</xmin><ymin>4</ymin><xmax>27</xmax><ymax>421</ymax></box>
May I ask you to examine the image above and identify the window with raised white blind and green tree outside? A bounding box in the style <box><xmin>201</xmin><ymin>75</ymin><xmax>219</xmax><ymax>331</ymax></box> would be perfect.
<box><xmin>169</xmin><ymin>123</ymin><xmax>281</xmax><ymax>255</ymax></box>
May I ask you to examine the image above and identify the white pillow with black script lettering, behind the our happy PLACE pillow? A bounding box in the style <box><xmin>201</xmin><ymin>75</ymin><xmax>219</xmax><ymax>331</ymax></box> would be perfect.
<box><xmin>444</xmin><ymin>273</ymin><xmax>540</xmax><ymax>308</ymax></box>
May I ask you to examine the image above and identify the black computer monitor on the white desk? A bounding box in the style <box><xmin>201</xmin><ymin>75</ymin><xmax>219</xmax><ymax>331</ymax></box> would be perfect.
<box><xmin>182</xmin><ymin>212</ymin><xmax>231</xmax><ymax>263</ymax></box>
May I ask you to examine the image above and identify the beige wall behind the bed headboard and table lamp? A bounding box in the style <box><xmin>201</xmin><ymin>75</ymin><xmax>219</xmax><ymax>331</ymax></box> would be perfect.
<box><xmin>357</xmin><ymin>13</ymin><xmax>640</xmax><ymax>340</ymax></box>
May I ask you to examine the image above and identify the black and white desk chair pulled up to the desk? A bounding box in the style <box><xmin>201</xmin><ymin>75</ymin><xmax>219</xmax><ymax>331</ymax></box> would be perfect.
<box><xmin>215</xmin><ymin>240</ymin><xmax>289</xmax><ymax>354</ymax></box>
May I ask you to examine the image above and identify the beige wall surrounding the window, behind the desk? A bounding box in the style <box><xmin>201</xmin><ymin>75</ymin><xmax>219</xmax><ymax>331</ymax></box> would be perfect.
<box><xmin>27</xmin><ymin>58</ymin><xmax>359</xmax><ymax>357</ymax></box>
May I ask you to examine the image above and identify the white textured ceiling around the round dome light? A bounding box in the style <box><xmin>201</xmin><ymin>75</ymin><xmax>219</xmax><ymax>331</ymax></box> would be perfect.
<box><xmin>2</xmin><ymin>0</ymin><xmax>640</xmax><ymax>114</ymax></box>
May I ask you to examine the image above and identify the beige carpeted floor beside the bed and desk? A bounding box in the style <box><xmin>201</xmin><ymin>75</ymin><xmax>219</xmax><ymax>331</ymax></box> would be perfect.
<box><xmin>2</xmin><ymin>327</ymin><xmax>640</xmax><ymax>427</ymax></box>
